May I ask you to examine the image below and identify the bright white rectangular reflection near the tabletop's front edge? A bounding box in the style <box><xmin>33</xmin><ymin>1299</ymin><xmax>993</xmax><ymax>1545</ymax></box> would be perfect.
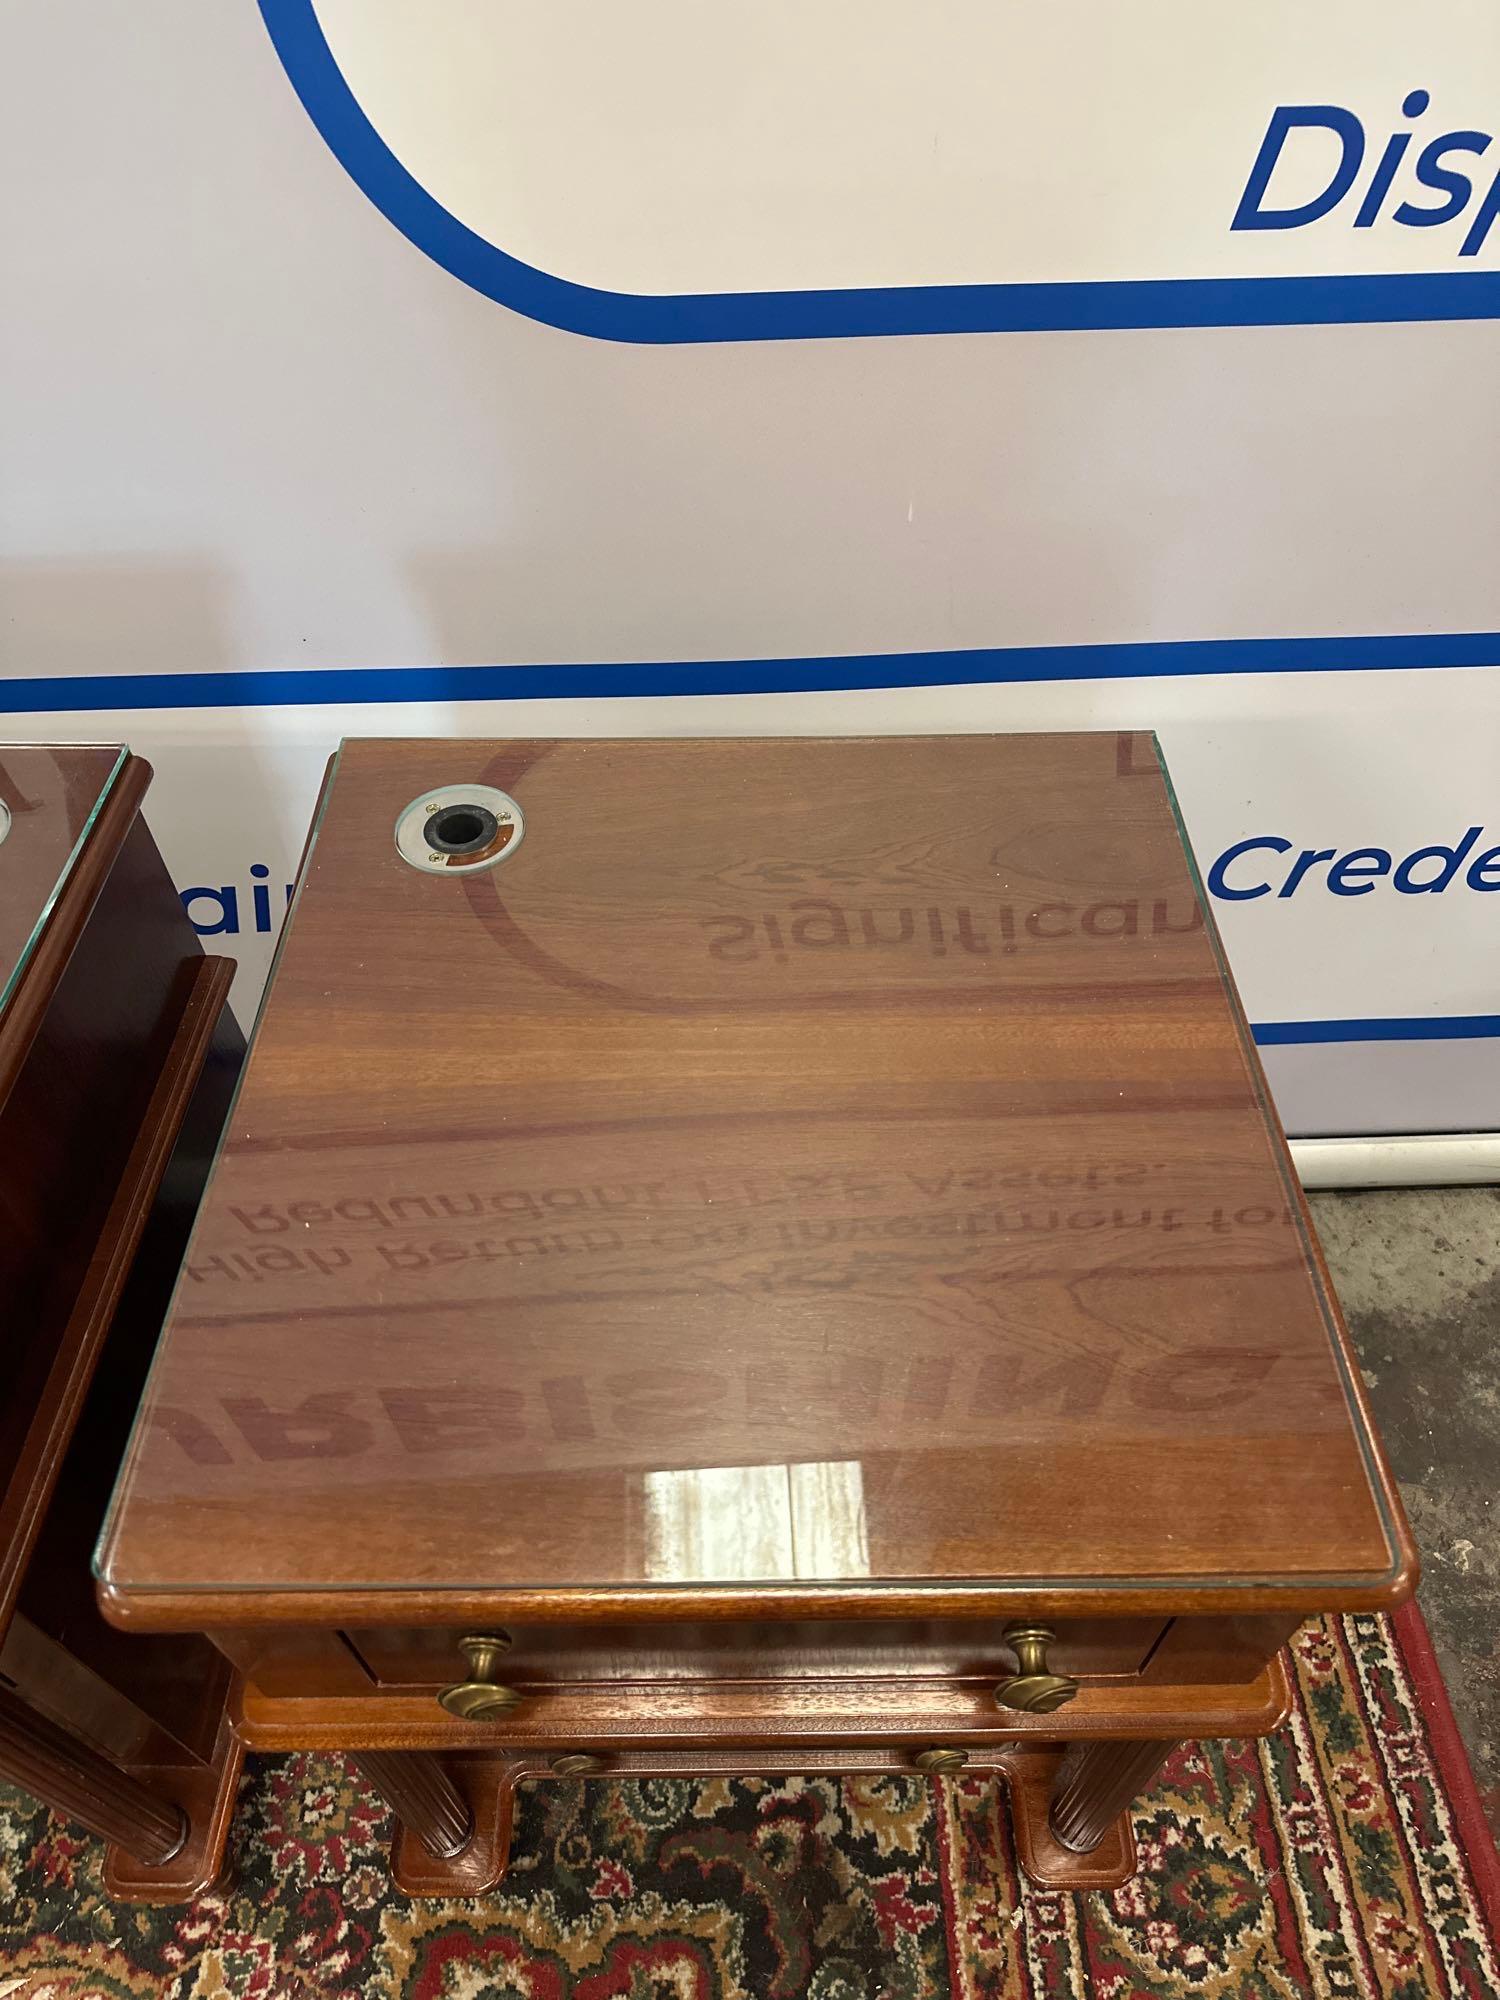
<box><xmin>646</xmin><ymin>1458</ymin><xmax>870</xmax><ymax>1584</ymax></box>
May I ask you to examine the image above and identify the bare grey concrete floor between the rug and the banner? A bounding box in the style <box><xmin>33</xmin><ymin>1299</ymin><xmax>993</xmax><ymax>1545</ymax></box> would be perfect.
<box><xmin>1312</xmin><ymin>1188</ymin><xmax>1500</xmax><ymax>1838</ymax></box>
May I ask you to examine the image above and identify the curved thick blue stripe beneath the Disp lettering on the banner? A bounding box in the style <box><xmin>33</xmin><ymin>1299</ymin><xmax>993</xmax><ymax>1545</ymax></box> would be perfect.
<box><xmin>260</xmin><ymin>0</ymin><xmax>1500</xmax><ymax>342</ymax></box>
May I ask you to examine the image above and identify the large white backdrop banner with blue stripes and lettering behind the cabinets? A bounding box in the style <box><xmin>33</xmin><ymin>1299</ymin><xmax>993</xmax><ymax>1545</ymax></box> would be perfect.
<box><xmin>0</xmin><ymin>0</ymin><xmax>1500</xmax><ymax>1134</ymax></box>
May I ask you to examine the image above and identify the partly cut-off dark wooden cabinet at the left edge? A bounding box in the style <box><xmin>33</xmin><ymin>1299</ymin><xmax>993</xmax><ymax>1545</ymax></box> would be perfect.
<box><xmin>0</xmin><ymin>744</ymin><xmax>242</xmax><ymax>1896</ymax></box>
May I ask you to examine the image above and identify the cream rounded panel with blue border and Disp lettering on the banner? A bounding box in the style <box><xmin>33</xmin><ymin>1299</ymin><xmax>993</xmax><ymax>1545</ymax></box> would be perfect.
<box><xmin>262</xmin><ymin>0</ymin><xmax>1500</xmax><ymax>324</ymax></box>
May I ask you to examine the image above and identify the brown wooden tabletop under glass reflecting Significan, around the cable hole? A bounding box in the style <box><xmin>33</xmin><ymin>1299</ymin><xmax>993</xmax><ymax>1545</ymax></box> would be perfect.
<box><xmin>100</xmin><ymin>734</ymin><xmax>1412</xmax><ymax>1622</ymax></box>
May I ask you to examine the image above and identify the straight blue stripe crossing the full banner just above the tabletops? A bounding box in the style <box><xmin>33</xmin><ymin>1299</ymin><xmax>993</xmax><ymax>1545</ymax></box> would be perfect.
<box><xmin>0</xmin><ymin>632</ymin><xmax>1500</xmax><ymax>716</ymax></box>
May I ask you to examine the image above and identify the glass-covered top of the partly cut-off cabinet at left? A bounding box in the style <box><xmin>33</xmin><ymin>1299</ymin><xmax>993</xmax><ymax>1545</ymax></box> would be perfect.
<box><xmin>0</xmin><ymin>744</ymin><xmax>130</xmax><ymax>1008</ymax></box>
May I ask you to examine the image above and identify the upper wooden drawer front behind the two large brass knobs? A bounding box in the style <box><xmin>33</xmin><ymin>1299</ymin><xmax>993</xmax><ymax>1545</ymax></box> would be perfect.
<box><xmin>344</xmin><ymin>1618</ymin><xmax>1168</xmax><ymax>1688</ymax></box>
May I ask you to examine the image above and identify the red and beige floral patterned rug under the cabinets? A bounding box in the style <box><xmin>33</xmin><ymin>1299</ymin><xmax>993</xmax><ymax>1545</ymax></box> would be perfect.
<box><xmin>0</xmin><ymin>1612</ymin><xmax>1500</xmax><ymax>2000</ymax></box>
